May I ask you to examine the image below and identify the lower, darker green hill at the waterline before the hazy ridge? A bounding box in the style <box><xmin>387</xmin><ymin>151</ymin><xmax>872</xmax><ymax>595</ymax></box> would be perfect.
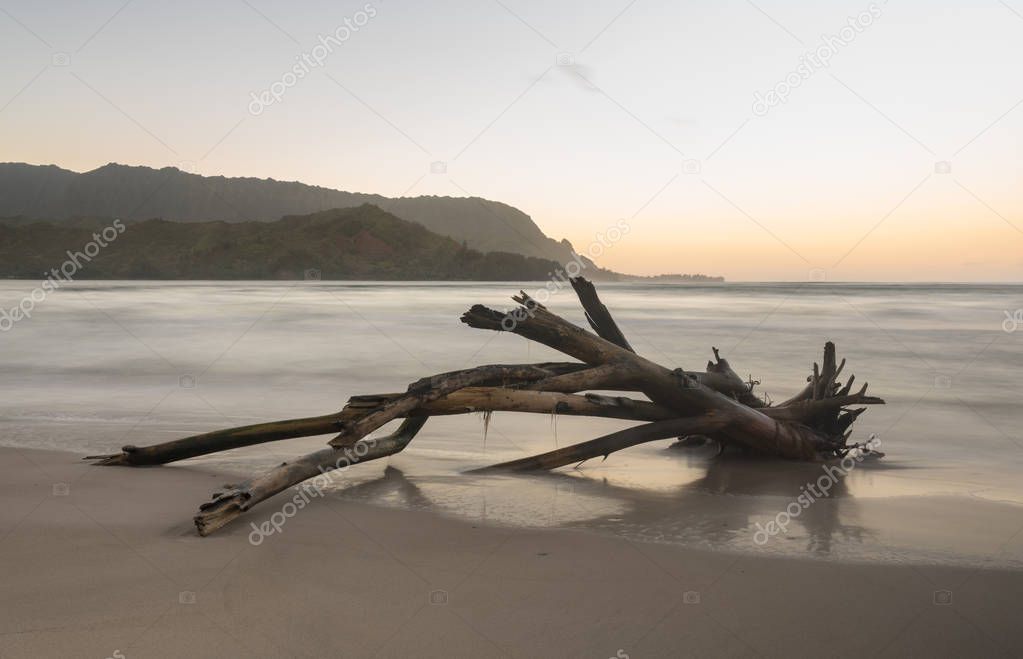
<box><xmin>0</xmin><ymin>204</ymin><xmax>585</xmax><ymax>280</ymax></box>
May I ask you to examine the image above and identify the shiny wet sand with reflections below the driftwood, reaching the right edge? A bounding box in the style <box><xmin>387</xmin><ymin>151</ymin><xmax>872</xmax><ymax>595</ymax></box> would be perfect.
<box><xmin>321</xmin><ymin>447</ymin><xmax>1023</xmax><ymax>568</ymax></box>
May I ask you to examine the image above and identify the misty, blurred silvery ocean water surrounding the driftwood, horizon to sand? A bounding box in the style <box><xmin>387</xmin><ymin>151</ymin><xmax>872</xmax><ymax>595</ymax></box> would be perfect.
<box><xmin>0</xmin><ymin>280</ymin><xmax>1023</xmax><ymax>566</ymax></box>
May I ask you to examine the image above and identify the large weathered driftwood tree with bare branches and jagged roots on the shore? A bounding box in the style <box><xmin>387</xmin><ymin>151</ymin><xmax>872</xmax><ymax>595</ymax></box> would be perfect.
<box><xmin>86</xmin><ymin>277</ymin><xmax>884</xmax><ymax>535</ymax></box>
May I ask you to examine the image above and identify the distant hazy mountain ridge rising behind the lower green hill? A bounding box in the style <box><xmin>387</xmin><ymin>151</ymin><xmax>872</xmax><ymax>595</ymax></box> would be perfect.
<box><xmin>0</xmin><ymin>163</ymin><xmax>595</xmax><ymax>267</ymax></box>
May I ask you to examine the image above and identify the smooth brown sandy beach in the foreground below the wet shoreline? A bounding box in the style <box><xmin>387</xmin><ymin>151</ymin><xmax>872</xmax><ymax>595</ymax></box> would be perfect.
<box><xmin>0</xmin><ymin>448</ymin><xmax>1023</xmax><ymax>658</ymax></box>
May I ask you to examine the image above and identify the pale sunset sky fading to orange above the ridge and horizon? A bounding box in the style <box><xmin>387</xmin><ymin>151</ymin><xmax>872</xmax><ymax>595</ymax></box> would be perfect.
<box><xmin>0</xmin><ymin>0</ymin><xmax>1023</xmax><ymax>281</ymax></box>
